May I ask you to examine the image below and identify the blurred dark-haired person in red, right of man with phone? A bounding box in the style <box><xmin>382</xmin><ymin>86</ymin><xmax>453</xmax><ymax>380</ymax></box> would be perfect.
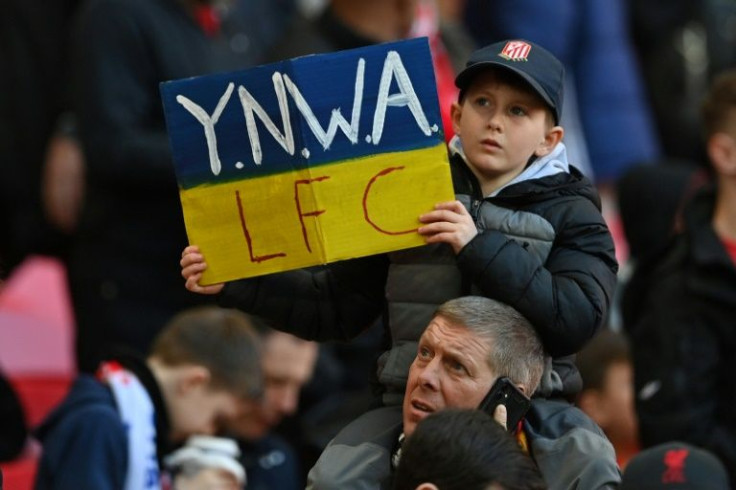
<box><xmin>576</xmin><ymin>328</ymin><xmax>639</xmax><ymax>468</ymax></box>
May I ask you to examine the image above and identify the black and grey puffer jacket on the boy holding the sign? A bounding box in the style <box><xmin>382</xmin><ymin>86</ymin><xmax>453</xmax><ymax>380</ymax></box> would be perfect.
<box><xmin>220</xmin><ymin>147</ymin><xmax>618</xmax><ymax>404</ymax></box>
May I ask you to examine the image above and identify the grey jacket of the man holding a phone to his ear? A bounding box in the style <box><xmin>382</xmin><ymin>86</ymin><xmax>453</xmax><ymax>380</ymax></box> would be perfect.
<box><xmin>307</xmin><ymin>399</ymin><xmax>621</xmax><ymax>490</ymax></box>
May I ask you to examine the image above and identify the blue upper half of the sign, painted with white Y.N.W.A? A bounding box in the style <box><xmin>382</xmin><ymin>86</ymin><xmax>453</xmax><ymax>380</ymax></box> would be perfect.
<box><xmin>161</xmin><ymin>38</ymin><xmax>444</xmax><ymax>188</ymax></box>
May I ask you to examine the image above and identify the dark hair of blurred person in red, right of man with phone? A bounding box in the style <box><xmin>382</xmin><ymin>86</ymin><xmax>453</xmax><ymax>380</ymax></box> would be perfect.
<box><xmin>575</xmin><ymin>328</ymin><xmax>631</xmax><ymax>390</ymax></box>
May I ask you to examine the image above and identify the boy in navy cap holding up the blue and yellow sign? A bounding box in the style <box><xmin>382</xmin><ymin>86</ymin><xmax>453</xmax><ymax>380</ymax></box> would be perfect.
<box><xmin>181</xmin><ymin>40</ymin><xmax>618</xmax><ymax>405</ymax></box>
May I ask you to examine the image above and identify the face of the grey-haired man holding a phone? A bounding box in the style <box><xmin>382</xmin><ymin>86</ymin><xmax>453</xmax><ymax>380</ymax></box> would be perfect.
<box><xmin>403</xmin><ymin>316</ymin><xmax>496</xmax><ymax>436</ymax></box>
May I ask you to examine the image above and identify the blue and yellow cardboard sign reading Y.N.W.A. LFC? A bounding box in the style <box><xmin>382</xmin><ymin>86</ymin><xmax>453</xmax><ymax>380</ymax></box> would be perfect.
<box><xmin>161</xmin><ymin>38</ymin><xmax>454</xmax><ymax>284</ymax></box>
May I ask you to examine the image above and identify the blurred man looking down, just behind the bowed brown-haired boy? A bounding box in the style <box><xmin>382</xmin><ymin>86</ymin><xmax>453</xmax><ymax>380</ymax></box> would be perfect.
<box><xmin>227</xmin><ymin>326</ymin><xmax>317</xmax><ymax>490</ymax></box>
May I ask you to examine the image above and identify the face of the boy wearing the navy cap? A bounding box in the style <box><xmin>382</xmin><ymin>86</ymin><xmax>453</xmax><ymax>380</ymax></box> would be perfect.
<box><xmin>451</xmin><ymin>70</ymin><xmax>562</xmax><ymax>194</ymax></box>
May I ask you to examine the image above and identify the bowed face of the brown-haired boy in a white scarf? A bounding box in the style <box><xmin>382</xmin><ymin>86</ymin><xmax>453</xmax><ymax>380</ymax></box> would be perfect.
<box><xmin>169</xmin><ymin>381</ymin><xmax>243</xmax><ymax>441</ymax></box>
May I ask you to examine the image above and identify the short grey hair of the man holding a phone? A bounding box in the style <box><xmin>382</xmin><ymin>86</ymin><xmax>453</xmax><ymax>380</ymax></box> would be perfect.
<box><xmin>435</xmin><ymin>296</ymin><xmax>544</xmax><ymax>393</ymax></box>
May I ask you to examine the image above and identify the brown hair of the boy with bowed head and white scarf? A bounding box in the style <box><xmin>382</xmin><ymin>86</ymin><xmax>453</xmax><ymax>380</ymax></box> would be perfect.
<box><xmin>151</xmin><ymin>306</ymin><xmax>263</xmax><ymax>398</ymax></box>
